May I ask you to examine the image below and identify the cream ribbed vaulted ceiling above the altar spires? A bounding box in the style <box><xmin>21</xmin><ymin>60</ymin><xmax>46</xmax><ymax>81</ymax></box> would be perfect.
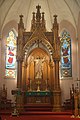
<box><xmin>0</xmin><ymin>0</ymin><xmax>80</xmax><ymax>30</ymax></box>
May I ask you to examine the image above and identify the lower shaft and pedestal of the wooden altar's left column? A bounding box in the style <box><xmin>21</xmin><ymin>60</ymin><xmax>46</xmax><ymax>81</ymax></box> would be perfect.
<box><xmin>16</xmin><ymin>58</ymin><xmax>23</xmax><ymax>112</ymax></box>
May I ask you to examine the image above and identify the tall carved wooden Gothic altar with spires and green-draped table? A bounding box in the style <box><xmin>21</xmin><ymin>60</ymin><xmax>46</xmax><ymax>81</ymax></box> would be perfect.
<box><xmin>13</xmin><ymin>5</ymin><xmax>61</xmax><ymax>111</ymax></box>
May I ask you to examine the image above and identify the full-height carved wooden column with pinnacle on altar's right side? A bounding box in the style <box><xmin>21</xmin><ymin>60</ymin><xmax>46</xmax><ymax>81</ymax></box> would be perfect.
<box><xmin>52</xmin><ymin>15</ymin><xmax>61</xmax><ymax>111</ymax></box>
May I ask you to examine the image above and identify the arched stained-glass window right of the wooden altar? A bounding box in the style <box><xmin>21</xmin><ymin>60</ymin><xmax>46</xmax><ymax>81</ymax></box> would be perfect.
<box><xmin>60</xmin><ymin>30</ymin><xmax>72</xmax><ymax>78</ymax></box>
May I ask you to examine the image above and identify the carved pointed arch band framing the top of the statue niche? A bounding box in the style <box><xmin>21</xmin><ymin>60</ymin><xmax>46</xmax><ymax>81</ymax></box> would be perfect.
<box><xmin>23</xmin><ymin>36</ymin><xmax>54</xmax><ymax>61</ymax></box>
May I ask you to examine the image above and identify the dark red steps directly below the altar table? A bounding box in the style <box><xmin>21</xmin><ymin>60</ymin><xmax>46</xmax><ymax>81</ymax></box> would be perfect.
<box><xmin>25</xmin><ymin>104</ymin><xmax>52</xmax><ymax>112</ymax></box>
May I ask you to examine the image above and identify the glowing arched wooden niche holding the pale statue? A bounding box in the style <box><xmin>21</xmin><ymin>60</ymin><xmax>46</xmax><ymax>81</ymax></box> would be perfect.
<box><xmin>27</xmin><ymin>49</ymin><xmax>49</xmax><ymax>91</ymax></box>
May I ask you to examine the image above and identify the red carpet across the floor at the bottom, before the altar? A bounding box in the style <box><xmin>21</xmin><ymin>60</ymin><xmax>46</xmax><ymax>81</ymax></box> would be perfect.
<box><xmin>1</xmin><ymin>112</ymin><xmax>80</xmax><ymax>120</ymax></box>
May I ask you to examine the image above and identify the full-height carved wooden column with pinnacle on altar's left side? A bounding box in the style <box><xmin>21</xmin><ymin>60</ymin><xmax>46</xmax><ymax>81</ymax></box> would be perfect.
<box><xmin>16</xmin><ymin>15</ymin><xmax>24</xmax><ymax>111</ymax></box>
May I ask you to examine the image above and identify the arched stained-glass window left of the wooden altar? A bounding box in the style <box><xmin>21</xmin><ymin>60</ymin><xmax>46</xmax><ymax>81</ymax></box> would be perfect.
<box><xmin>5</xmin><ymin>30</ymin><xmax>17</xmax><ymax>78</ymax></box>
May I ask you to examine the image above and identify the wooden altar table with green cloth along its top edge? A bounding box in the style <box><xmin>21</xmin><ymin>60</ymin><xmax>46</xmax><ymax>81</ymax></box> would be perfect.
<box><xmin>26</xmin><ymin>91</ymin><xmax>51</xmax><ymax>104</ymax></box>
